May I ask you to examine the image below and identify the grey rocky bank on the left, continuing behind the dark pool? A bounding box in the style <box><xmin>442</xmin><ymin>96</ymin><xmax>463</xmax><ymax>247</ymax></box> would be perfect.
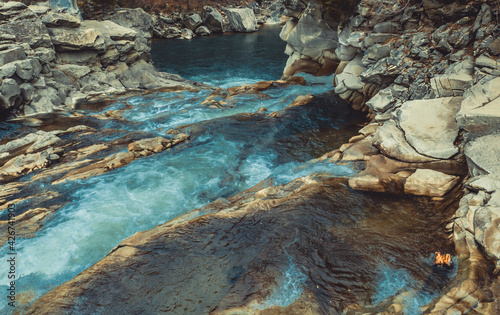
<box><xmin>0</xmin><ymin>1</ymin><xmax>283</xmax><ymax>119</ymax></box>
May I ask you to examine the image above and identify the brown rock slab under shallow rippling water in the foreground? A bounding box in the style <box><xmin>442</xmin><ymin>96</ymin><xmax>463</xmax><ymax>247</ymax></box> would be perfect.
<box><xmin>26</xmin><ymin>176</ymin><xmax>453</xmax><ymax>314</ymax></box>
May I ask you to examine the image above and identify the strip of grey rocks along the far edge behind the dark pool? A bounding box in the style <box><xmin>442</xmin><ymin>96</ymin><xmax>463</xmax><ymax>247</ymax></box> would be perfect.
<box><xmin>153</xmin><ymin>0</ymin><xmax>284</xmax><ymax>39</ymax></box>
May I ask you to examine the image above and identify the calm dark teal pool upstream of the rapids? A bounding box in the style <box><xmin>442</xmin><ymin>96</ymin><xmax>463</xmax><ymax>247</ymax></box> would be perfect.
<box><xmin>152</xmin><ymin>25</ymin><xmax>287</xmax><ymax>87</ymax></box>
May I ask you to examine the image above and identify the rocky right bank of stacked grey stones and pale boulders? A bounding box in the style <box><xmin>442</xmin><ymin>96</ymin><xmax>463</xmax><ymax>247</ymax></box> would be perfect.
<box><xmin>281</xmin><ymin>0</ymin><xmax>500</xmax><ymax>314</ymax></box>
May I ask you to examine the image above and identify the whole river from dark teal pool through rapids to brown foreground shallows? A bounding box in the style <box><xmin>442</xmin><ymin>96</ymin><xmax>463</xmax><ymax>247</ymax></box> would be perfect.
<box><xmin>0</xmin><ymin>27</ymin><xmax>458</xmax><ymax>314</ymax></box>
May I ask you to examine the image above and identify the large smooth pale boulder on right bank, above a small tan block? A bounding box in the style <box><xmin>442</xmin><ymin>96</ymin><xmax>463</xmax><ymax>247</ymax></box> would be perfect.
<box><xmin>397</xmin><ymin>97</ymin><xmax>462</xmax><ymax>159</ymax></box>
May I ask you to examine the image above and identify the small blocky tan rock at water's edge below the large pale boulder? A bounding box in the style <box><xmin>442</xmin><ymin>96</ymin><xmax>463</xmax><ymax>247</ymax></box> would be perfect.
<box><xmin>404</xmin><ymin>169</ymin><xmax>460</xmax><ymax>197</ymax></box>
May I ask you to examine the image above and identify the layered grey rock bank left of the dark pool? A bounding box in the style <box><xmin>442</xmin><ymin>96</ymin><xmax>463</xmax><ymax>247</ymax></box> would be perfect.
<box><xmin>0</xmin><ymin>1</ymin><xmax>201</xmax><ymax>118</ymax></box>
